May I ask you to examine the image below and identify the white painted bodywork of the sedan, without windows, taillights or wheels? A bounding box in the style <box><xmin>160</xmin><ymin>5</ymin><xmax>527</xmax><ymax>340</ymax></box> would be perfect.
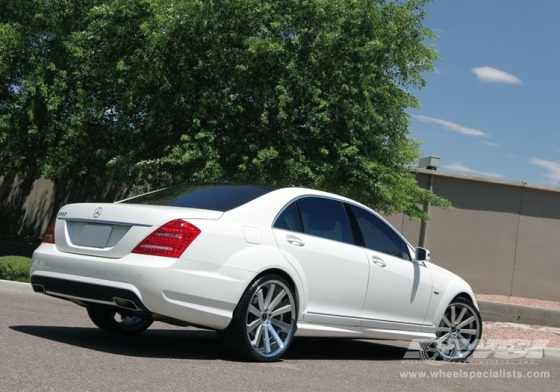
<box><xmin>31</xmin><ymin>184</ymin><xmax>478</xmax><ymax>346</ymax></box>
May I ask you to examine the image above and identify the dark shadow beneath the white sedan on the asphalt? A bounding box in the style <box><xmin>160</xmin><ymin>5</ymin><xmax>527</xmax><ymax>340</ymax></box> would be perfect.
<box><xmin>9</xmin><ymin>325</ymin><xmax>407</xmax><ymax>361</ymax></box>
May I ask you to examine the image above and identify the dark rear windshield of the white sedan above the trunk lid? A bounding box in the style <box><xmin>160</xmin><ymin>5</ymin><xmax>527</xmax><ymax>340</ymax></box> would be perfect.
<box><xmin>121</xmin><ymin>182</ymin><xmax>278</xmax><ymax>211</ymax></box>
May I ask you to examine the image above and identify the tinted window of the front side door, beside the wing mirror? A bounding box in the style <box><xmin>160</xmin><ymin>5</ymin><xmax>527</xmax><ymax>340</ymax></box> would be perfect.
<box><xmin>350</xmin><ymin>205</ymin><xmax>410</xmax><ymax>260</ymax></box>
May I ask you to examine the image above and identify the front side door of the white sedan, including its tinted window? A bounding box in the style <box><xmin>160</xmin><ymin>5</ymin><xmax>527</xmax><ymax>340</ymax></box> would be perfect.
<box><xmin>350</xmin><ymin>205</ymin><xmax>432</xmax><ymax>331</ymax></box>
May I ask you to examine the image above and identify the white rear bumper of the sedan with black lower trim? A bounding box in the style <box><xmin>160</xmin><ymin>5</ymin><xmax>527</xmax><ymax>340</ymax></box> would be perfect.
<box><xmin>30</xmin><ymin>244</ymin><xmax>254</xmax><ymax>329</ymax></box>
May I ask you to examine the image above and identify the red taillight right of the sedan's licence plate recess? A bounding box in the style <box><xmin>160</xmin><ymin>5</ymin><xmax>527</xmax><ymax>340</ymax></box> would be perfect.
<box><xmin>132</xmin><ymin>219</ymin><xmax>200</xmax><ymax>257</ymax></box>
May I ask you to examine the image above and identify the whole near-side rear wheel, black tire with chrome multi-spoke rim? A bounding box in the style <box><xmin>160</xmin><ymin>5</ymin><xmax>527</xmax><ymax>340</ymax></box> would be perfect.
<box><xmin>218</xmin><ymin>274</ymin><xmax>297</xmax><ymax>362</ymax></box>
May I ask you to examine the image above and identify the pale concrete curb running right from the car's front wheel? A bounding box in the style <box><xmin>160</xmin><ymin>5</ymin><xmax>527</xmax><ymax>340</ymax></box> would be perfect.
<box><xmin>478</xmin><ymin>301</ymin><xmax>560</xmax><ymax>327</ymax></box>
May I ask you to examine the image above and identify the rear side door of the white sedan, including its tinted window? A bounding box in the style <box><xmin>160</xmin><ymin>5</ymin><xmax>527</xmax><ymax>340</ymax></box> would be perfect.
<box><xmin>273</xmin><ymin>196</ymin><xmax>370</xmax><ymax>326</ymax></box>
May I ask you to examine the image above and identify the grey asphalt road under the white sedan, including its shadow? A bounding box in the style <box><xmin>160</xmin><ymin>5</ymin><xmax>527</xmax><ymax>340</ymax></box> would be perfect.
<box><xmin>0</xmin><ymin>287</ymin><xmax>560</xmax><ymax>391</ymax></box>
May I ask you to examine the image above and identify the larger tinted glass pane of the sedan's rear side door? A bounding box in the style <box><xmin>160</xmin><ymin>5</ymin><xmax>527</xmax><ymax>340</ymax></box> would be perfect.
<box><xmin>297</xmin><ymin>197</ymin><xmax>354</xmax><ymax>244</ymax></box>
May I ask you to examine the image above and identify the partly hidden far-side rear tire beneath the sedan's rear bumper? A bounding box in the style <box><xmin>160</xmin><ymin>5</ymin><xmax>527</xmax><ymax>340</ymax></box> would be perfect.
<box><xmin>87</xmin><ymin>308</ymin><xmax>153</xmax><ymax>335</ymax></box>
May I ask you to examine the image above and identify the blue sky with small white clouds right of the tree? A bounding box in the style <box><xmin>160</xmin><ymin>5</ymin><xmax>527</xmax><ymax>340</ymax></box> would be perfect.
<box><xmin>408</xmin><ymin>0</ymin><xmax>560</xmax><ymax>187</ymax></box>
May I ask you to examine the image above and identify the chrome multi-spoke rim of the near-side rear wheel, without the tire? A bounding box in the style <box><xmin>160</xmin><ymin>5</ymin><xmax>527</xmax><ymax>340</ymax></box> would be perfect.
<box><xmin>246</xmin><ymin>280</ymin><xmax>295</xmax><ymax>357</ymax></box>
